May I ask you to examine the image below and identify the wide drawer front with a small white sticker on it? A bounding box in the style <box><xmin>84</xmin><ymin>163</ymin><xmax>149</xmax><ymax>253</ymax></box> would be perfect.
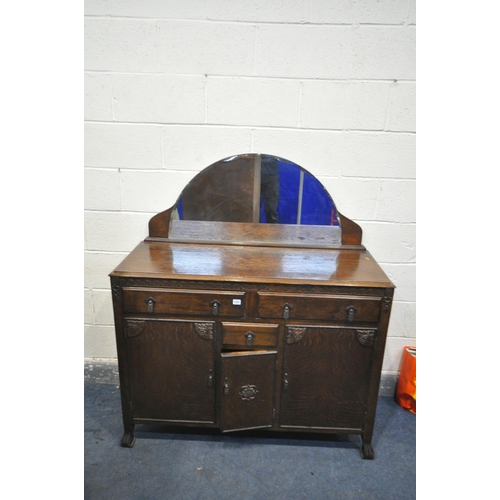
<box><xmin>123</xmin><ymin>288</ymin><xmax>245</xmax><ymax>317</ymax></box>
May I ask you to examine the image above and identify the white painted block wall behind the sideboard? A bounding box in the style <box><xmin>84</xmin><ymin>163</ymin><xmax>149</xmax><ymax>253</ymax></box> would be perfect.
<box><xmin>84</xmin><ymin>0</ymin><xmax>416</xmax><ymax>375</ymax></box>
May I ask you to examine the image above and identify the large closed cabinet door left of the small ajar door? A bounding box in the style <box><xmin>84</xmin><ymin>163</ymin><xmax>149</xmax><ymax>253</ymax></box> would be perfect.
<box><xmin>125</xmin><ymin>319</ymin><xmax>215</xmax><ymax>423</ymax></box>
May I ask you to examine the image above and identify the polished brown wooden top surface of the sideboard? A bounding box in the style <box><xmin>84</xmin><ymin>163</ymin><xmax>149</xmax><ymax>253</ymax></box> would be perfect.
<box><xmin>110</xmin><ymin>241</ymin><xmax>394</xmax><ymax>288</ymax></box>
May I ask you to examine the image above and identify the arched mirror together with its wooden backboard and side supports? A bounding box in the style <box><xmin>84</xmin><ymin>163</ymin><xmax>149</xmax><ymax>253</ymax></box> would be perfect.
<box><xmin>149</xmin><ymin>153</ymin><xmax>362</xmax><ymax>246</ymax></box>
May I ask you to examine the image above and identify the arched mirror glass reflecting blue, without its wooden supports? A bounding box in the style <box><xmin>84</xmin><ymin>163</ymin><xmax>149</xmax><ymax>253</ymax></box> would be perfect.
<box><xmin>172</xmin><ymin>154</ymin><xmax>339</xmax><ymax>226</ymax></box>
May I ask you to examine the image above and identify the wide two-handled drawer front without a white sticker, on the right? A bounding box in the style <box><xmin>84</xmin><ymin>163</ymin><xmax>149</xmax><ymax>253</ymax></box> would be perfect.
<box><xmin>258</xmin><ymin>292</ymin><xmax>381</xmax><ymax>323</ymax></box>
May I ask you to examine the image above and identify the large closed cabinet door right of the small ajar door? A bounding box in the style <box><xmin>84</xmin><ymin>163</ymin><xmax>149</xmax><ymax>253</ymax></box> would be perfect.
<box><xmin>280</xmin><ymin>326</ymin><xmax>376</xmax><ymax>430</ymax></box>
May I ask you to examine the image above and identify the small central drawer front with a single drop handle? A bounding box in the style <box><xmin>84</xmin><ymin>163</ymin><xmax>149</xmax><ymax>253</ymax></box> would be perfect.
<box><xmin>222</xmin><ymin>323</ymin><xmax>279</xmax><ymax>347</ymax></box>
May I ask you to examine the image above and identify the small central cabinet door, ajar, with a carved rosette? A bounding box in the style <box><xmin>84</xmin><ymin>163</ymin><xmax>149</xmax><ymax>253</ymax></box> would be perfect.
<box><xmin>221</xmin><ymin>351</ymin><xmax>277</xmax><ymax>432</ymax></box>
